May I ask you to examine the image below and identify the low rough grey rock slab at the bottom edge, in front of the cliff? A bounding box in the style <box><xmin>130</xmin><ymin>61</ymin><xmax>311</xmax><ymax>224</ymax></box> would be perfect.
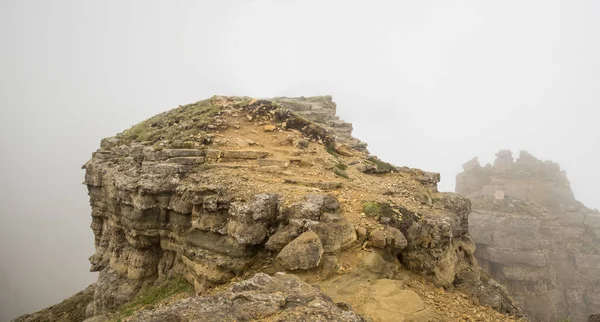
<box><xmin>130</xmin><ymin>273</ymin><xmax>365</xmax><ymax>322</ymax></box>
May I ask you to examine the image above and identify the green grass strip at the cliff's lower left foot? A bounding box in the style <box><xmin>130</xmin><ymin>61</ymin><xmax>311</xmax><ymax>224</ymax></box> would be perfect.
<box><xmin>112</xmin><ymin>276</ymin><xmax>194</xmax><ymax>321</ymax></box>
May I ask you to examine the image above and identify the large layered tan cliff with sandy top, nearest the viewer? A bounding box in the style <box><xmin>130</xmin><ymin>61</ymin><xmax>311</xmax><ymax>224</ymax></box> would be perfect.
<box><xmin>16</xmin><ymin>96</ymin><xmax>521</xmax><ymax>321</ymax></box>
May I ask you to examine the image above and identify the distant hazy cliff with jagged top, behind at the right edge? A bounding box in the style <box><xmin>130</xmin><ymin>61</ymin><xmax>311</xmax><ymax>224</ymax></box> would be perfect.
<box><xmin>456</xmin><ymin>150</ymin><xmax>600</xmax><ymax>321</ymax></box>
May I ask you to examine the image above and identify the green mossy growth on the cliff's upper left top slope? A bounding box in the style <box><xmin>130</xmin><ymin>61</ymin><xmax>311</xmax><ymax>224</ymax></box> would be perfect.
<box><xmin>117</xmin><ymin>99</ymin><xmax>220</xmax><ymax>143</ymax></box>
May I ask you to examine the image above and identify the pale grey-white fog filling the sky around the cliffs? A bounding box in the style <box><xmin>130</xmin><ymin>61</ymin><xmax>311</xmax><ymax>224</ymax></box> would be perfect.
<box><xmin>0</xmin><ymin>0</ymin><xmax>600</xmax><ymax>320</ymax></box>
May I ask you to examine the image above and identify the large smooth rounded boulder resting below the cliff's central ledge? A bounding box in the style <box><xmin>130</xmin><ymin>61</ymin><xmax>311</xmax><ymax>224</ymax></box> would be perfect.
<box><xmin>276</xmin><ymin>231</ymin><xmax>323</xmax><ymax>271</ymax></box>
